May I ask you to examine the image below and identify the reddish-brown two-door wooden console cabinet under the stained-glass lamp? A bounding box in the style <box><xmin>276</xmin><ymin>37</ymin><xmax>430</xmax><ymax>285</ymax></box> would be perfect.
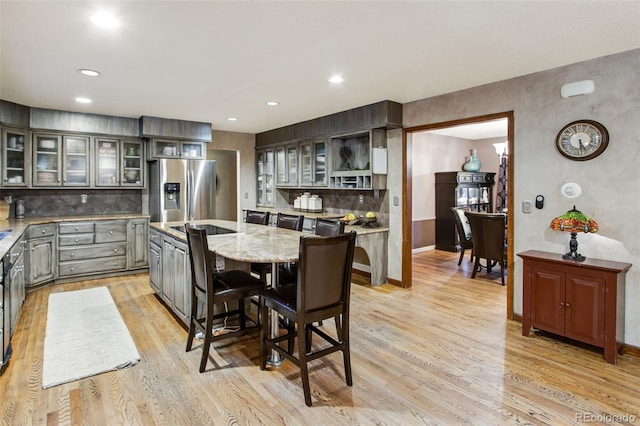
<box><xmin>518</xmin><ymin>250</ymin><xmax>631</xmax><ymax>364</ymax></box>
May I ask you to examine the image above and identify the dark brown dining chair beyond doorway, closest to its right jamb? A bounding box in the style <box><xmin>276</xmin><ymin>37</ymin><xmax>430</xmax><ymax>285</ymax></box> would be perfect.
<box><xmin>465</xmin><ymin>212</ymin><xmax>507</xmax><ymax>285</ymax></box>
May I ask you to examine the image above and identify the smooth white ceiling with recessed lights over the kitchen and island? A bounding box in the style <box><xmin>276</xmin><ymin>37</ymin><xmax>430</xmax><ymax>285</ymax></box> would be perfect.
<box><xmin>0</xmin><ymin>0</ymin><xmax>640</xmax><ymax>133</ymax></box>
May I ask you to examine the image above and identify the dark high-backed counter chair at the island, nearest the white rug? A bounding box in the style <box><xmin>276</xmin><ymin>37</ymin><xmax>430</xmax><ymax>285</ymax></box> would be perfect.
<box><xmin>185</xmin><ymin>223</ymin><xmax>265</xmax><ymax>373</ymax></box>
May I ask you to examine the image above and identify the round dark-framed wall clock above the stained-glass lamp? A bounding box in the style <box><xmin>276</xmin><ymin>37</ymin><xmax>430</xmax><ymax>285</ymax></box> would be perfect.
<box><xmin>556</xmin><ymin>120</ymin><xmax>609</xmax><ymax>161</ymax></box>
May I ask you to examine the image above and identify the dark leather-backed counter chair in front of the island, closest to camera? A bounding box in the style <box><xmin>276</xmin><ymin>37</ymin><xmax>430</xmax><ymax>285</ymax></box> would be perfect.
<box><xmin>260</xmin><ymin>231</ymin><xmax>356</xmax><ymax>406</ymax></box>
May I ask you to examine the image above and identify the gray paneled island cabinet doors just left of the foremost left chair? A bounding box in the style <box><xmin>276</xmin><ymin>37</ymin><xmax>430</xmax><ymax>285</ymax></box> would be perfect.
<box><xmin>160</xmin><ymin>235</ymin><xmax>191</xmax><ymax>324</ymax></box>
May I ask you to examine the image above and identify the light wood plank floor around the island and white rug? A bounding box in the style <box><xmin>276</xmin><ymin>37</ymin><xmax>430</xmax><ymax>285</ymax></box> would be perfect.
<box><xmin>0</xmin><ymin>251</ymin><xmax>640</xmax><ymax>425</ymax></box>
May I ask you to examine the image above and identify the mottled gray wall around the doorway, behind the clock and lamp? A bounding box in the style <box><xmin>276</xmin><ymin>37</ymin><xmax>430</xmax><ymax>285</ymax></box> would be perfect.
<box><xmin>398</xmin><ymin>49</ymin><xmax>640</xmax><ymax>346</ymax></box>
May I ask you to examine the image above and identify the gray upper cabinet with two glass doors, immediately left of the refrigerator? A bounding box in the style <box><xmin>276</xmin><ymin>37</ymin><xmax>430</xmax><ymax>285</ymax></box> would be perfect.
<box><xmin>95</xmin><ymin>139</ymin><xmax>145</xmax><ymax>187</ymax></box>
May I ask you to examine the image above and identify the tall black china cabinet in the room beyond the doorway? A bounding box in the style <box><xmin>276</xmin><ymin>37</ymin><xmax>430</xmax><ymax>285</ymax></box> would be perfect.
<box><xmin>435</xmin><ymin>172</ymin><xmax>495</xmax><ymax>252</ymax></box>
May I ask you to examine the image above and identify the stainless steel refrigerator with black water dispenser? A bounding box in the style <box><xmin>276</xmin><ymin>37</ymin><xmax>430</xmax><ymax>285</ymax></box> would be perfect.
<box><xmin>149</xmin><ymin>159</ymin><xmax>216</xmax><ymax>222</ymax></box>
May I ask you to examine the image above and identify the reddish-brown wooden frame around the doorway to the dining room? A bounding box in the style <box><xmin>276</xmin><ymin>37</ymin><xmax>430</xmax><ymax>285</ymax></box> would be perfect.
<box><xmin>402</xmin><ymin>111</ymin><xmax>514</xmax><ymax>319</ymax></box>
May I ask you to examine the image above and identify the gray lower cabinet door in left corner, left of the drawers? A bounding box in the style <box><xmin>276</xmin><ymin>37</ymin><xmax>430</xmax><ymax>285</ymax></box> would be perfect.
<box><xmin>25</xmin><ymin>223</ymin><xmax>56</xmax><ymax>287</ymax></box>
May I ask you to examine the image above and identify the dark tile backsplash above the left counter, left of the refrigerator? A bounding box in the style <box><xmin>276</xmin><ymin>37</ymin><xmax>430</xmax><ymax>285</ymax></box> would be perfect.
<box><xmin>0</xmin><ymin>189</ymin><xmax>142</xmax><ymax>217</ymax></box>
